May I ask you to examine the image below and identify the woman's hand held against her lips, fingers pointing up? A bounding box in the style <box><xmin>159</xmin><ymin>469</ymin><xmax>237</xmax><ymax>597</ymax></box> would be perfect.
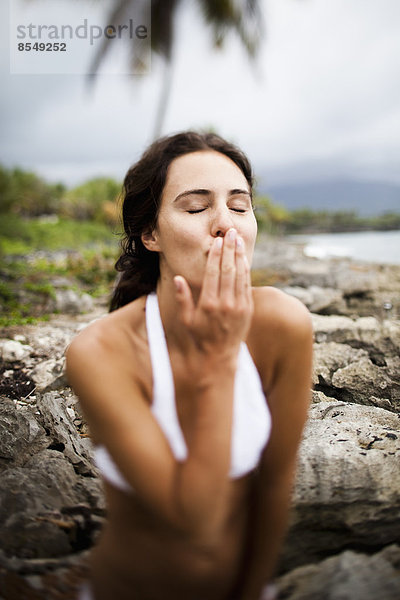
<box><xmin>174</xmin><ymin>229</ymin><xmax>253</xmax><ymax>359</ymax></box>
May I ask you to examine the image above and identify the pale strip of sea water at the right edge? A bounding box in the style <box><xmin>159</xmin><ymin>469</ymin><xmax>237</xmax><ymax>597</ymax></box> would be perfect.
<box><xmin>289</xmin><ymin>230</ymin><xmax>400</xmax><ymax>265</ymax></box>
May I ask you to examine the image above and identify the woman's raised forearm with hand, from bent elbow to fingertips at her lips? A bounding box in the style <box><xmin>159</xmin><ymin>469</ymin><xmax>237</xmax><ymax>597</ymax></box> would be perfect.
<box><xmin>162</xmin><ymin>229</ymin><xmax>253</xmax><ymax>535</ymax></box>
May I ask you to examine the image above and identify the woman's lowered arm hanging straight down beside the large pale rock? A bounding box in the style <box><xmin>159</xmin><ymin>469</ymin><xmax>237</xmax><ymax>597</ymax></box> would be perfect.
<box><xmin>238</xmin><ymin>288</ymin><xmax>312</xmax><ymax>600</ymax></box>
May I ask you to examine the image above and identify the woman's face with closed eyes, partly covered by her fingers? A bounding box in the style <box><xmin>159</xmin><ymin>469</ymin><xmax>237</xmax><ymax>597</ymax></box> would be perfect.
<box><xmin>143</xmin><ymin>150</ymin><xmax>257</xmax><ymax>291</ymax></box>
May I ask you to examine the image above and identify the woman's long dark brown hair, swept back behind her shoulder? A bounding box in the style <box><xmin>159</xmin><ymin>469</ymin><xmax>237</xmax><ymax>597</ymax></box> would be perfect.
<box><xmin>110</xmin><ymin>131</ymin><xmax>253</xmax><ymax>311</ymax></box>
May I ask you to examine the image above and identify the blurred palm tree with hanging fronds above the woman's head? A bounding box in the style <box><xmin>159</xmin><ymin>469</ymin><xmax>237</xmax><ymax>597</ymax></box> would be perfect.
<box><xmin>90</xmin><ymin>0</ymin><xmax>263</xmax><ymax>138</ymax></box>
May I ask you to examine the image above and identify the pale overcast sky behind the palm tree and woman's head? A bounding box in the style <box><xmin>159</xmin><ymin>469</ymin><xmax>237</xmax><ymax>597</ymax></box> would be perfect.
<box><xmin>0</xmin><ymin>0</ymin><xmax>400</xmax><ymax>185</ymax></box>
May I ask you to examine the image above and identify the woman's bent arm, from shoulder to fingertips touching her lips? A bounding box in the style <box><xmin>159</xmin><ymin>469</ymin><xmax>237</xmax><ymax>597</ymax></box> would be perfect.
<box><xmin>67</xmin><ymin>229</ymin><xmax>253</xmax><ymax>538</ymax></box>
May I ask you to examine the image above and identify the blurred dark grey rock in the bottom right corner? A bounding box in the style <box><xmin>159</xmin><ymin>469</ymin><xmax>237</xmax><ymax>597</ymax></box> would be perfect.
<box><xmin>277</xmin><ymin>545</ymin><xmax>400</xmax><ymax>600</ymax></box>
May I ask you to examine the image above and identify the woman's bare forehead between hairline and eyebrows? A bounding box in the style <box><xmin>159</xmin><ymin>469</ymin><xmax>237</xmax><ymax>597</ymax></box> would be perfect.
<box><xmin>163</xmin><ymin>150</ymin><xmax>249</xmax><ymax>196</ymax></box>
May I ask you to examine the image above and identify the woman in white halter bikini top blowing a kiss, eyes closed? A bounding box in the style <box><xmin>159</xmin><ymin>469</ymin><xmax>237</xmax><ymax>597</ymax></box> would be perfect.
<box><xmin>67</xmin><ymin>132</ymin><xmax>312</xmax><ymax>600</ymax></box>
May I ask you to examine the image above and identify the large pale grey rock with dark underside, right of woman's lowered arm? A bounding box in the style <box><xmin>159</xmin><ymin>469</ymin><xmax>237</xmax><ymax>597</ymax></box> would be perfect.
<box><xmin>284</xmin><ymin>402</ymin><xmax>400</xmax><ymax>568</ymax></box>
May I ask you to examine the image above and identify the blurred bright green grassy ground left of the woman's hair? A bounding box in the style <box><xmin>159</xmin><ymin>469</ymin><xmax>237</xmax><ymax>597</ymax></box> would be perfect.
<box><xmin>0</xmin><ymin>215</ymin><xmax>118</xmax><ymax>326</ymax></box>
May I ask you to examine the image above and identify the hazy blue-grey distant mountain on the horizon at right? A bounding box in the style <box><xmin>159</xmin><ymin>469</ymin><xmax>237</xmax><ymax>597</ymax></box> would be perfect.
<box><xmin>257</xmin><ymin>179</ymin><xmax>400</xmax><ymax>217</ymax></box>
